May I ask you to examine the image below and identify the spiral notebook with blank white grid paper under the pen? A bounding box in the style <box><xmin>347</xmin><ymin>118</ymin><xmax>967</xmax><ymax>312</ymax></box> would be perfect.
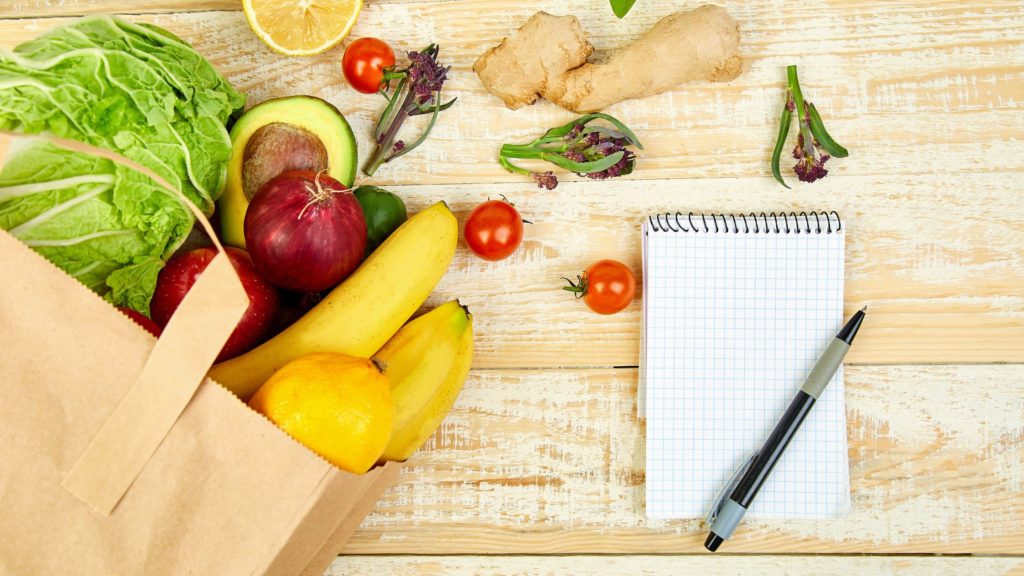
<box><xmin>638</xmin><ymin>212</ymin><xmax>850</xmax><ymax>519</ymax></box>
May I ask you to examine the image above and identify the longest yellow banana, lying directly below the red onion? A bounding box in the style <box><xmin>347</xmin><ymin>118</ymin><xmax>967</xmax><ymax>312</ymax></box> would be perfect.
<box><xmin>210</xmin><ymin>202</ymin><xmax>459</xmax><ymax>400</ymax></box>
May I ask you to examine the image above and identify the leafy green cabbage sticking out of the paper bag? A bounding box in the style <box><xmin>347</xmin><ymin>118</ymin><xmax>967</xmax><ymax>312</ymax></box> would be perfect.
<box><xmin>0</xmin><ymin>16</ymin><xmax>245</xmax><ymax>314</ymax></box>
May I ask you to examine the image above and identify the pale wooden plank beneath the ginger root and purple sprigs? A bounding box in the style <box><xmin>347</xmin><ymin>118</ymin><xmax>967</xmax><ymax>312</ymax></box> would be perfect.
<box><xmin>0</xmin><ymin>0</ymin><xmax>1024</xmax><ymax>188</ymax></box>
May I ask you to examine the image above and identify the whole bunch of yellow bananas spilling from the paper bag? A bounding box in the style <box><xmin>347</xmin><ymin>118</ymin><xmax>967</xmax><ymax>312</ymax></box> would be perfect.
<box><xmin>216</xmin><ymin>202</ymin><xmax>473</xmax><ymax>461</ymax></box>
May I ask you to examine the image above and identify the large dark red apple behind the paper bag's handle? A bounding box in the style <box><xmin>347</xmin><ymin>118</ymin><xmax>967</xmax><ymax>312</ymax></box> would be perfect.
<box><xmin>150</xmin><ymin>247</ymin><xmax>281</xmax><ymax>362</ymax></box>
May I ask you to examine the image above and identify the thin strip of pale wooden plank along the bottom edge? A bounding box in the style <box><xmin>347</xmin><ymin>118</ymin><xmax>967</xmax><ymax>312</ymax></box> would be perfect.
<box><xmin>325</xmin><ymin>554</ymin><xmax>1024</xmax><ymax>576</ymax></box>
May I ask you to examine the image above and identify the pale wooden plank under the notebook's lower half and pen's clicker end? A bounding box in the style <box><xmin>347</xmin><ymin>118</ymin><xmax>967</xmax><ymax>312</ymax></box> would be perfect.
<box><xmin>345</xmin><ymin>366</ymin><xmax>1024</xmax><ymax>553</ymax></box>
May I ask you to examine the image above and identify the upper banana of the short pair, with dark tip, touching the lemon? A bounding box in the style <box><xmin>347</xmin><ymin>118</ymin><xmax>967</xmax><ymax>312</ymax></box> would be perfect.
<box><xmin>374</xmin><ymin>300</ymin><xmax>469</xmax><ymax>429</ymax></box>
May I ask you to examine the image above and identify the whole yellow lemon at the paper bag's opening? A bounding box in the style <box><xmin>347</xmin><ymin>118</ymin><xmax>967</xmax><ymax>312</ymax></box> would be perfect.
<box><xmin>249</xmin><ymin>353</ymin><xmax>394</xmax><ymax>474</ymax></box>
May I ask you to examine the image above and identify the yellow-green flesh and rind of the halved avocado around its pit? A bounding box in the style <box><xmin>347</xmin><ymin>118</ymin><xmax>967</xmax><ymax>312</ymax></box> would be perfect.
<box><xmin>217</xmin><ymin>96</ymin><xmax>358</xmax><ymax>248</ymax></box>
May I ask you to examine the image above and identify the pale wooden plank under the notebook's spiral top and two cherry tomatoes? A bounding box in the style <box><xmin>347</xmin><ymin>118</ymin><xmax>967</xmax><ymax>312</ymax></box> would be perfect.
<box><xmin>394</xmin><ymin>174</ymin><xmax>1024</xmax><ymax>368</ymax></box>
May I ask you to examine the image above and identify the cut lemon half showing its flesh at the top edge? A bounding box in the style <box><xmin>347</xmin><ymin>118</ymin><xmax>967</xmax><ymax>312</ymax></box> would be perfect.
<box><xmin>242</xmin><ymin>0</ymin><xmax>362</xmax><ymax>56</ymax></box>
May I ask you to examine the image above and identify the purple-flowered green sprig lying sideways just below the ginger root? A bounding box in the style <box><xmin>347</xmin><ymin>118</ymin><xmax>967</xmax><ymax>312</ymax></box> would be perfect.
<box><xmin>498</xmin><ymin>114</ymin><xmax>643</xmax><ymax>190</ymax></box>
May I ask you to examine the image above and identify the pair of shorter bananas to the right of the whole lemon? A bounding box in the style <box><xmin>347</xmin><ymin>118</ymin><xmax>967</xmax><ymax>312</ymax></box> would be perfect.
<box><xmin>374</xmin><ymin>300</ymin><xmax>473</xmax><ymax>461</ymax></box>
